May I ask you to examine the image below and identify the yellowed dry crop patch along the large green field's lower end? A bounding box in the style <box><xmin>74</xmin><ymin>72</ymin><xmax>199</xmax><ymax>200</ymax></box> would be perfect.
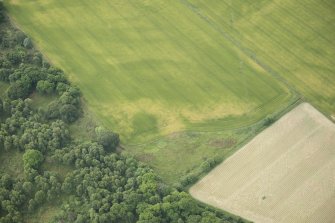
<box><xmin>96</xmin><ymin>99</ymin><xmax>255</xmax><ymax>135</ymax></box>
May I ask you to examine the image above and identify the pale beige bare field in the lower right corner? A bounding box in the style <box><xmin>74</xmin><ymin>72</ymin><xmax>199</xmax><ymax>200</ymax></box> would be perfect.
<box><xmin>190</xmin><ymin>103</ymin><xmax>335</xmax><ymax>223</ymax></box>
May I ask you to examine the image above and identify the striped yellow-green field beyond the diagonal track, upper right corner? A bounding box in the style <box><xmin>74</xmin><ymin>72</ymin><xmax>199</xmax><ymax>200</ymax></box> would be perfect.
<box><xmin>183</xmin><ymin>0</ymin><xmax>335</xmax><ymax>116</ymax></box>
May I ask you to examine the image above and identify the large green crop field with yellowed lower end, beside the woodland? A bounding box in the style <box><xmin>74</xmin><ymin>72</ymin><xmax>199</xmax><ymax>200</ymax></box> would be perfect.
<box><xmin>6</xmin><ymin>0</ymin><xmax>292</xmax><ymax>144</ymax></box>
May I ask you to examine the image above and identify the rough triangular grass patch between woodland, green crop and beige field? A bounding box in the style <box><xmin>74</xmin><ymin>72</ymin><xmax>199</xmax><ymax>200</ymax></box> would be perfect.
<box><xmin>126</xmin><ymin>126</ymin><xmax>252</xmax><ymax>184</ymax></box>
